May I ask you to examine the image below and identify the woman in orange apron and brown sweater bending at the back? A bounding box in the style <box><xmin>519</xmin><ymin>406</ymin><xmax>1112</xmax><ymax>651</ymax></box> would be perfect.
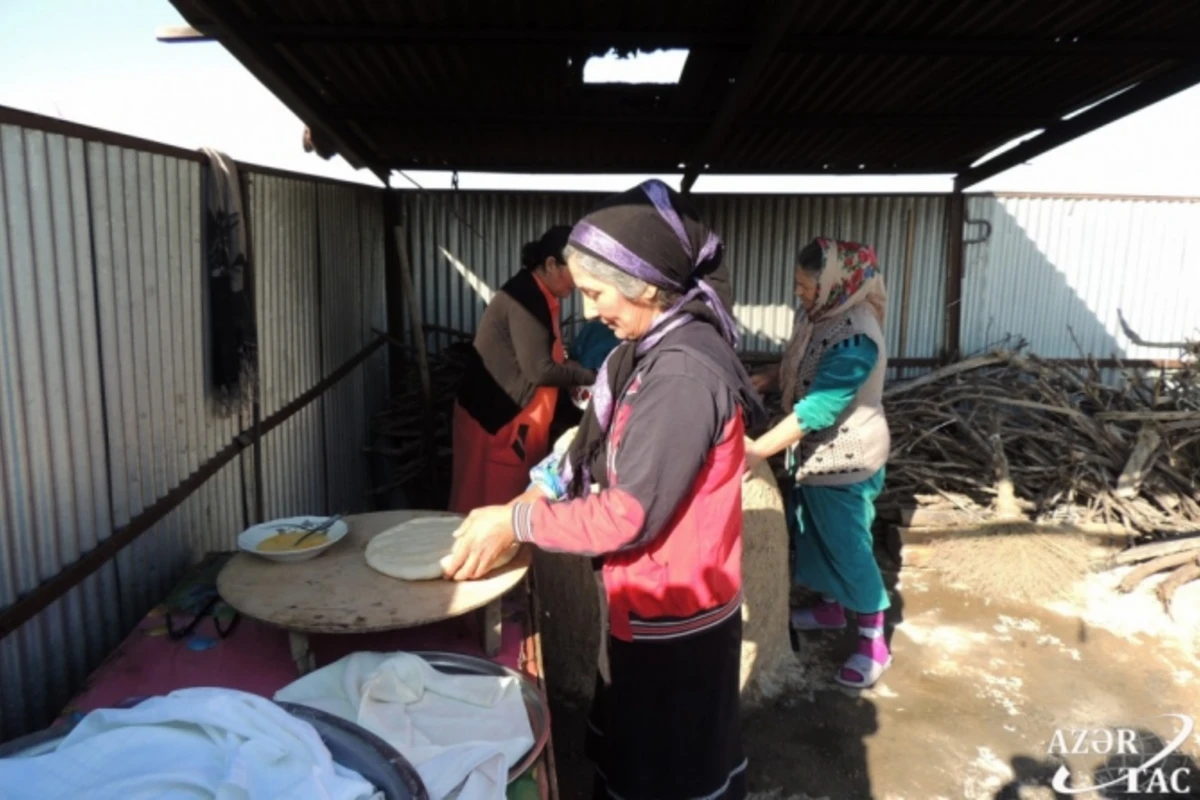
<box><xmin>450</xmin><ymin>225</ymin><xmax>595</xmax><ymax>513</ymax></box>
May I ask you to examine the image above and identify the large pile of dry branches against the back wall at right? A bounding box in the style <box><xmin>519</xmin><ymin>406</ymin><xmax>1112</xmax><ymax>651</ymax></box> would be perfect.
<box><xmin>881</xmin><ymin>351</ymin><xmax>1200</xmax><ymax>536</ymax></box>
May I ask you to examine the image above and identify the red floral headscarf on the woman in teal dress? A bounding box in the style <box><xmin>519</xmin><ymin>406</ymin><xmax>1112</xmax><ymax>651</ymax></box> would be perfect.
<box><xmin>779</xmin><ymin>239</ymin><xmax>888</xmax><ymax>408</ymax></box>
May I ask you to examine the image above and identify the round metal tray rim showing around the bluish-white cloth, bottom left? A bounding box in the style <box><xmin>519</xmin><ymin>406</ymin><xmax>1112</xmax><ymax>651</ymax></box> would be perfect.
<box><xmin>0</xmin><ymin>702</ymin><xmax>430</xmax><ymax>800</ymax></box>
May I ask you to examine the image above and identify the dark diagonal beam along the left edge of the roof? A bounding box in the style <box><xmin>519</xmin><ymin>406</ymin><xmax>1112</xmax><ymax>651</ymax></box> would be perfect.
<box><xmin>177</xmin><ymin>0</ymin><xmax>388</xmax><ymax>186</ymax></box>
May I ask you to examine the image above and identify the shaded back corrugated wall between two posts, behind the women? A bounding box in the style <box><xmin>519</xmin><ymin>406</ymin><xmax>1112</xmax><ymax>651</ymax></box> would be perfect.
<box><xmin>402</xmin><ymin>192</ymin><xmax>946</xmax><ymax>357</ymax></box>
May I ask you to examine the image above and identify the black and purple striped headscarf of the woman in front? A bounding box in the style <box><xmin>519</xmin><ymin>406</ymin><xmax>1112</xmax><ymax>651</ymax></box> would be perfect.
<box><xmin>563</xmin><ymin>180</ymin><xmax>738</xmax><ymax>497</ymax></box>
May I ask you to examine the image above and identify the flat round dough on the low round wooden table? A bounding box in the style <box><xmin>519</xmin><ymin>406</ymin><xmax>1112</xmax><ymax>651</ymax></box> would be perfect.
<box><xmin>366</xmin><ymin>517</ymin><xmax>520</xmax><ymax>581</ymax></box>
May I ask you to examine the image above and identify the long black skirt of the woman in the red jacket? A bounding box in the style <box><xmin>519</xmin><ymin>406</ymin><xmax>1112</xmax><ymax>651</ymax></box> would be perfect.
<box><xmin>587</xmin><ymin>613</ymin><xmax>746</xmax><ymax>800</ymax></box>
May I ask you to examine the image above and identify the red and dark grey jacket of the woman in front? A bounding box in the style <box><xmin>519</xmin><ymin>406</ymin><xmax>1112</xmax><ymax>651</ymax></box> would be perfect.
<box><xmin>514</xmin><ymin>323</ymin><xmax>758</xmax><ymax>640</ymax></box>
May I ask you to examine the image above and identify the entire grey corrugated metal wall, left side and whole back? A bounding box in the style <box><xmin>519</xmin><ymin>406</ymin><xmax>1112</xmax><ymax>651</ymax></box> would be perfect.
<box><xmin>0</xmin><ymin>126</ymin><xmax>1200</xmax><ymax>739</ymax></box>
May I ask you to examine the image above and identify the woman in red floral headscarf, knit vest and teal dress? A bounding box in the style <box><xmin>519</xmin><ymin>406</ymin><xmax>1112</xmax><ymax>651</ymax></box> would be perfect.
<box><xmin>746</xmin><ymin>239</ymin><xmax>892</xmax><ymax>688</ymax></box>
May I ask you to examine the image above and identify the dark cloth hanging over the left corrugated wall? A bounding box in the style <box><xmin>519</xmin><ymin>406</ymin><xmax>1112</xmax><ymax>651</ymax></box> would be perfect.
<box><xmin>202</xmin><ymin>148</ymin><xmax>258</xmax><ymax>414</ymax></box>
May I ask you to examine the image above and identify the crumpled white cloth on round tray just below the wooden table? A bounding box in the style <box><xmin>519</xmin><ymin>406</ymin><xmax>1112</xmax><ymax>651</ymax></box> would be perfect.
<box><xmin>275</xmin><ymin>652</ymin><xmax>533</xmax><ymax>800</ymax></box>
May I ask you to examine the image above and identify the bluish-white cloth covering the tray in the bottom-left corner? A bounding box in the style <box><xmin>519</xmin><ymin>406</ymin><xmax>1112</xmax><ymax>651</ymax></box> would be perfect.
<box><xmin>0</xmin><ymin>688</ymin><xmax>376</xmax><ymax>800</ymax></box>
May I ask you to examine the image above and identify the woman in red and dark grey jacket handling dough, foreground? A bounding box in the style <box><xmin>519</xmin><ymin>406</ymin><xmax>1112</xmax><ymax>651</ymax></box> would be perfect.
<box><xmin>444</xmin><ymin>181</ymin><xmax>762</xmax><ymax>800</ymax></box>
